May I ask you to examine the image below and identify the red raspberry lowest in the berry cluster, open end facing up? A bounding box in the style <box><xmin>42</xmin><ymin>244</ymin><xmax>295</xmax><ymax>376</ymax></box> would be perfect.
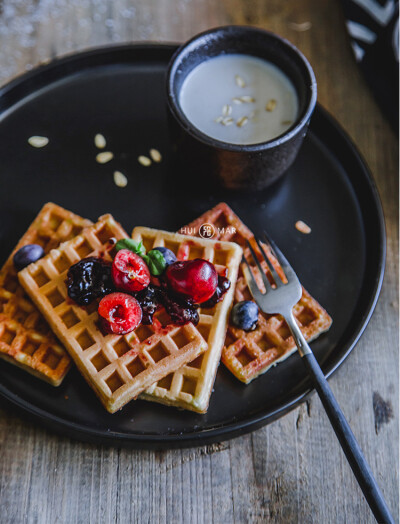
<box><xmin>98</xmin><ymin>293</ymin><xmax>142</xmax><ymax>335</ymax></box>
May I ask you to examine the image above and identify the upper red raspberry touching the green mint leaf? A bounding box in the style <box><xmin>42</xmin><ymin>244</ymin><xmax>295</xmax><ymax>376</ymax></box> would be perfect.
<box><xmin>111</xmin><ymin>249</ymin><xmax>150</xmax><ymax>293</ymax></box>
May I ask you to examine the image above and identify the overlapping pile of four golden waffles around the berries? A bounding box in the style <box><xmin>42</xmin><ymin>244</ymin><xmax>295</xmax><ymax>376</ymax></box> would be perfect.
<box><xmin>0</xmin><ymin>203</ymin><xmax>332</xmax><ymax>413</ymax></box>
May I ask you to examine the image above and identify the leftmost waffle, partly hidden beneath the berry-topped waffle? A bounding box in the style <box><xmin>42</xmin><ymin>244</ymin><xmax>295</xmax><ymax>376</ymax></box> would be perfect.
<box><xmin>0</xmin><ymin>203</ymin><xmax>91</xmax><ymax>386</ymax></box>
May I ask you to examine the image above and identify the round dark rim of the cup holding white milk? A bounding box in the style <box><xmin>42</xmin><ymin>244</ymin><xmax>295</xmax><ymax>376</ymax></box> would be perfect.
<box><xmin>167</xmin><ymin>25</ymin><xmax>317</xmax><ymax>152</ymax></box>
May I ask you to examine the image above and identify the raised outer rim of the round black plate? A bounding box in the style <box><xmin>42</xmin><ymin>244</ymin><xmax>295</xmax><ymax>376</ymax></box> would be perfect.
<box><xmin>0</xmin><ymin>42</ymin><xmax>386</xmax><ymax>449</ymax></box>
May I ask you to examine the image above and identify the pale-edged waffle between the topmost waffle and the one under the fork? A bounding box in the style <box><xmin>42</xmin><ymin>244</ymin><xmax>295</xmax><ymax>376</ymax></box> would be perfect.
<box><xmin>132</xmin><ymin>227</ymin><xmax>242</xmax><ymax>413</ymax></box>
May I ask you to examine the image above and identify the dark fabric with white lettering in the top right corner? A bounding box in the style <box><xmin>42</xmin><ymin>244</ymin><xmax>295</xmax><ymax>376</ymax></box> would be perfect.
<box><xmin>342</xmin><ymin>0</ymin><xmax>399</xmax><ymax>133</ymax></box>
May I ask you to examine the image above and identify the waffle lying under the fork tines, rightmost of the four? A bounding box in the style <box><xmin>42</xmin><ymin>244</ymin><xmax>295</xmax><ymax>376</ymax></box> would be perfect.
<box><xmin>181</xmin><ymin>203</ymin><xmax>332</xmax><ymax>384</ymax></box>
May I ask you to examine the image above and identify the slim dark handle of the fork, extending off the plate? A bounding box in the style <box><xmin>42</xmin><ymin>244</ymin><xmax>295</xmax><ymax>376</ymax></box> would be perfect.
<box><xmin>286</xmin><ymin>315</ymin><xmax>394</xmax><ymax>524</ymax></box>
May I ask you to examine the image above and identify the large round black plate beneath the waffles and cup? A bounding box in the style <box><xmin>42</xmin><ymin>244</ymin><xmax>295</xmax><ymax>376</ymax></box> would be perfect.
<box><xmin>0</xmin><ymin>45</ymin><xmax>385</xmax><ymax>447</ymax></box>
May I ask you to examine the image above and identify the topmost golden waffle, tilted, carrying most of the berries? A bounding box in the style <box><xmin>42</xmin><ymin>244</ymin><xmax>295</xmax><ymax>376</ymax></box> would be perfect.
<box><xmin>19</xmin><ymin>215</ymin><xmax>207</xmax><ymax>413</ymax></box>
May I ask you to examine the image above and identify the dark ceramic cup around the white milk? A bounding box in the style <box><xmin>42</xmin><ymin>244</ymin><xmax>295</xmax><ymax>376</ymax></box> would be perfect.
<box><xmin>167</xmin><ymin>26</ymin><xmax>317</xmax><ymax>189</ymax></box>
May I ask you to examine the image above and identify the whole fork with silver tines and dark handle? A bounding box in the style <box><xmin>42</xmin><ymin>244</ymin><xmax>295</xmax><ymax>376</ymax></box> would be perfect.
<box><xmin>243</xmin><ymin>232</ymin><xmax>394</xmax><ymax>524</ymax></box>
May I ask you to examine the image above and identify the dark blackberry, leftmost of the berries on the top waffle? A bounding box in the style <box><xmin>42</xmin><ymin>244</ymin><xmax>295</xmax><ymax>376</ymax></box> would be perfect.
<box><xmin>67</xmin><ymin>257</ymin><xmax>115</xmax><ymax>306</ymax></box>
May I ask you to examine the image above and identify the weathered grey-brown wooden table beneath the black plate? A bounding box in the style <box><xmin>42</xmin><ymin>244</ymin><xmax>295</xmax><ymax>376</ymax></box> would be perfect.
<box><xmin>0</xmin><ymin>0</ymin><xmax>398</xmax><ymax>524</ymax></box>
